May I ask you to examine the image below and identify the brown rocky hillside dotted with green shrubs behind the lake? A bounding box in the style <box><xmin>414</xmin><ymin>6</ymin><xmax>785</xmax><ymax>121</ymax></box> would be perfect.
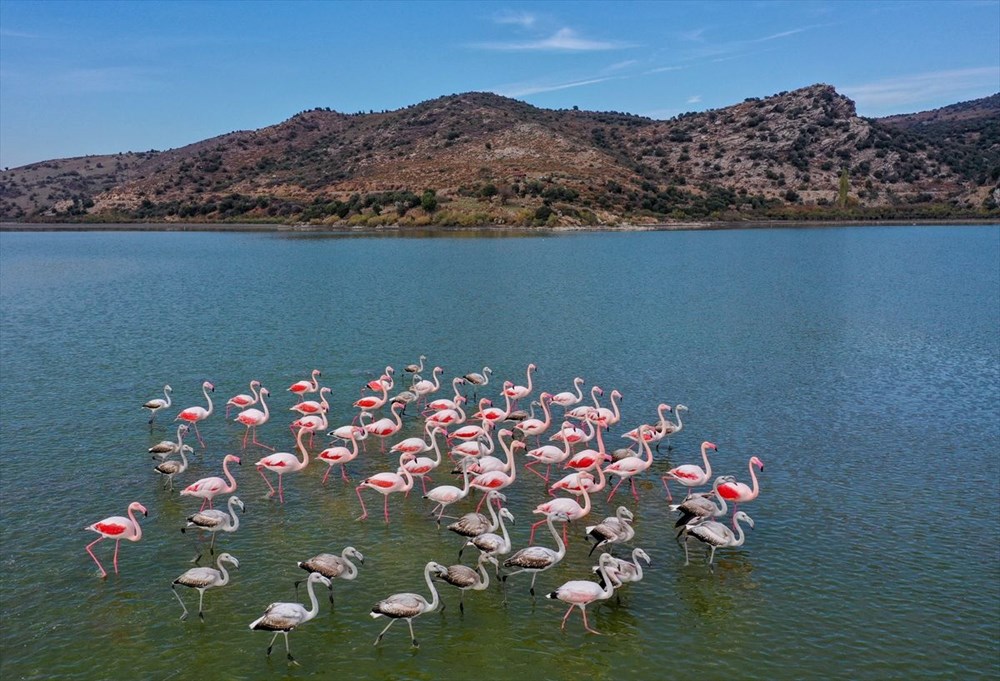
<box><xmin>0</xmin><ymin>85</ymin><xmax>1000</xmax><ymax>226</ymax></box>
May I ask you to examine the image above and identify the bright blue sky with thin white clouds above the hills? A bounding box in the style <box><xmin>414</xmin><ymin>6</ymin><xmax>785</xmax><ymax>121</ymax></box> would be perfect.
<box><xmin>0</xmin><ymin>0</ymin><xmax>1000</xmax><ymax>168</ymax></box>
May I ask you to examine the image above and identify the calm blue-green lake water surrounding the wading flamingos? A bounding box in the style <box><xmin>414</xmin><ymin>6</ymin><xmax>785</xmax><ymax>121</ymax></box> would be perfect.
<box><xmin>0</xmin><ymin>226</ymin><xmax>1000</xmax><ymax>679</ymax></box>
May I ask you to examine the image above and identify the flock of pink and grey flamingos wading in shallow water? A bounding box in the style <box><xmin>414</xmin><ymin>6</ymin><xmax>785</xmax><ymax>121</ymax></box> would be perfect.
<box><xmin>85</xmin><ymin>356</ymin><xmax>764</xmax><ymax>663</ymax></box>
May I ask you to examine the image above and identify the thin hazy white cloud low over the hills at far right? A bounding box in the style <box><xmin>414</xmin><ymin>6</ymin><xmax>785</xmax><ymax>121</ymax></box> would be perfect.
<box><xmin>838</xmin><ymin>66</ymin><xmax>1000</xmax><ymax>109</ymax></box>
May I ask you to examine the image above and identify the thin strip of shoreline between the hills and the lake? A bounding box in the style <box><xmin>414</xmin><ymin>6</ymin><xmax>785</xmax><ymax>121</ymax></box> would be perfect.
<box><xmin>0</xmin><ymin>218</ymin><xmax>1000</xmax><ymax>235</ymax></box>
